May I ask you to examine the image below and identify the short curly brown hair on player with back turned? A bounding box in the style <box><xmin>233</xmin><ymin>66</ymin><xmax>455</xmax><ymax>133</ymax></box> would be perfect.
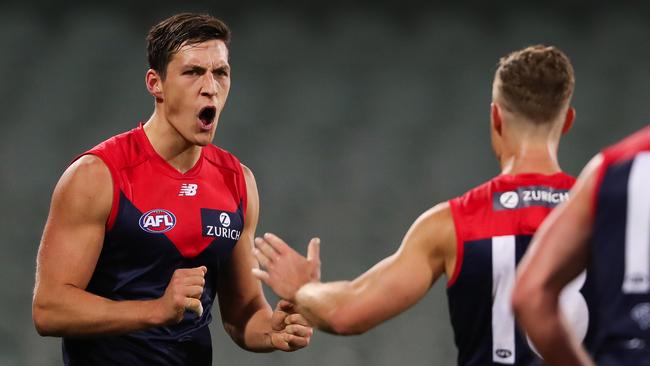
<box><xmin>496</xmin><ymin>45</ymin><xmax>575</xmax><ymax>123</ymax></box>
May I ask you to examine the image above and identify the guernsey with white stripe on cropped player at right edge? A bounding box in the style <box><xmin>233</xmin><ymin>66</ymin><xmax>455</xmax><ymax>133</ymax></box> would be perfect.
<box><xmin>589</xmin><ymin>126</ymin><xmax>650</xmax><ymax>365</ymax></box>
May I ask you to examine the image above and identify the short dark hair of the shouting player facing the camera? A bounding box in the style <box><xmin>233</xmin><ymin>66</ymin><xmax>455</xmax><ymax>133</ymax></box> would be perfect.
<box><xmin>147</xmin><ymin>13</ymin><xmax>230</xmax><ymax>79</ymax></box>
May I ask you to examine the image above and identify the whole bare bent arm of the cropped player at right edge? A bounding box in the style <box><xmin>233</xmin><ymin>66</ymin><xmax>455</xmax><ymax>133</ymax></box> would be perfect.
<box><xmin>513</xmin><ymin>156</ymin><xmax>601</xmax><ymax>365</ymax></box>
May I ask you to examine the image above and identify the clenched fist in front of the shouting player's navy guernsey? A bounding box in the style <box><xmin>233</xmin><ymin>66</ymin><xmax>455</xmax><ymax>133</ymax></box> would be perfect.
<box><xmin>158</xmin><ymin>266</ymin><xmax>208</xmax><ymax>324</ymax></box>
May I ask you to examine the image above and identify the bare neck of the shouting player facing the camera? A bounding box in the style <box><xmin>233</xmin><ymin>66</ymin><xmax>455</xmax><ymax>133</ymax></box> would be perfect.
<box><xmin>144</xmin><ymin>112</ymin><xmax>201</xmax><ymax>173</ymax></box>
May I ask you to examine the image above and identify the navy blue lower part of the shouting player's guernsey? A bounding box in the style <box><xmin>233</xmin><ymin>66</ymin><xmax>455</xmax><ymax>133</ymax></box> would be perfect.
<box><xmin>63</xmin><ymin>195</ymin><xmax>240</xmax><ymax>366</ymax></box>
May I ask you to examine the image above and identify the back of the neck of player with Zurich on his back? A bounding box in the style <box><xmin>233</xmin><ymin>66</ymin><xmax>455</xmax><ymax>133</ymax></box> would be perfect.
<box><xmin>500</xmin><ymin>141</ymin><xmax>562</xmax><ymax>175</ymax></box>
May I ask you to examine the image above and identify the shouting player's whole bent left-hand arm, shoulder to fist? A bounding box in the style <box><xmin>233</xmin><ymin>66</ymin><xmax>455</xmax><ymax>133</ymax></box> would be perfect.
<box><xmin>32</xmin><ymin>155</ymin><xmax>205</xmax><ymax>336</ymax></box>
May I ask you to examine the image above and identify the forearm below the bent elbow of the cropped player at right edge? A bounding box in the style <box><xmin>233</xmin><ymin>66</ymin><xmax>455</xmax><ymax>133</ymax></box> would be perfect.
<box><xmin>515</xmin><ymin>294</ymin><xmax>593</xmax><ymax>366</ymax></box>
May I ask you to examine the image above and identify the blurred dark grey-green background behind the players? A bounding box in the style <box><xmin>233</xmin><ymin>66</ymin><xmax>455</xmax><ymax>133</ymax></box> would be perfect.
<box><xmin>0</xmin><ymin>0</ymin><xmax>650</xmax><ymax>366</ymax></box>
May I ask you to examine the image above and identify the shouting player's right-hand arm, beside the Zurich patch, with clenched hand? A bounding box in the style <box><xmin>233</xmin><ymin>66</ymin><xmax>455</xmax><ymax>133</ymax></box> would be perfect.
<box><xmin>218</xmin><ymin>166</ymin><xmax>313</xmax><ymax>352</ymax></box>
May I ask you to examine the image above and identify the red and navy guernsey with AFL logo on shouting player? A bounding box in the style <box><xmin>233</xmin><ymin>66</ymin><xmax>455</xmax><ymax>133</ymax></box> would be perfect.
<box><xmin>63</xmin><ymin>125</ymin><xmax>246</xmax><ymax>366</ymax></box>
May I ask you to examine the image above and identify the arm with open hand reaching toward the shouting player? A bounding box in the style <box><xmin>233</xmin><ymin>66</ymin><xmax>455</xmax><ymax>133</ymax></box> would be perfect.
<box><xmin>254</xmin><ymin>203</ymin><xmax>456</xmax><ymax>334</ymax></box>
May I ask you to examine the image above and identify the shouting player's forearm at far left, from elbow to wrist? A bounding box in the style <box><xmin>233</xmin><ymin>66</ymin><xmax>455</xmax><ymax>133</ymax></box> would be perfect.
<box><xmin>32</xmin><ymin>285</ymin><xmax>162</xmax><ymax>337</ymax></box>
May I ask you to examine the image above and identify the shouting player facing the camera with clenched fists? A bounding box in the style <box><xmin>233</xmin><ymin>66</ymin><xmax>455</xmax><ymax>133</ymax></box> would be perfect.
<box><xmin>33</xmin><ymin>14</ymin><xmax>312</xmax><ymax>366</ymax></box>
